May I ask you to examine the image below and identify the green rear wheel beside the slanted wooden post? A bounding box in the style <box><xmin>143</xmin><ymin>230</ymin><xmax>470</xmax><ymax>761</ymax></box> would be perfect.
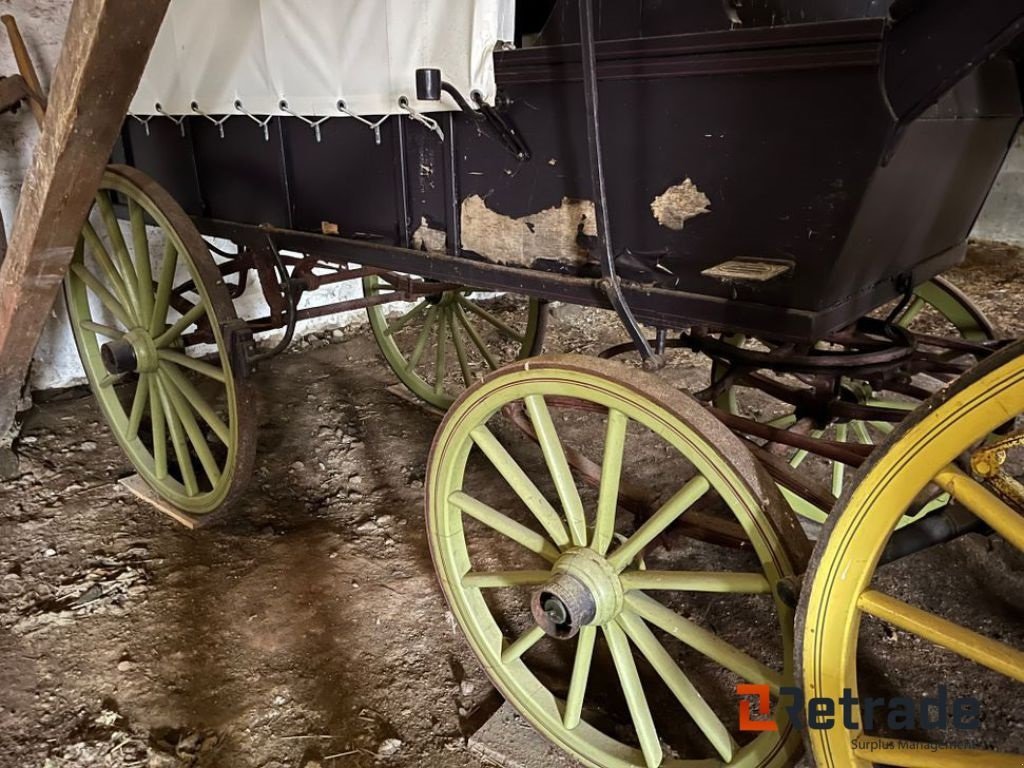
<box><xmin>65</xmin><ymin>166</ymin><xmax>256</xmax><ymax>515</ymax></box>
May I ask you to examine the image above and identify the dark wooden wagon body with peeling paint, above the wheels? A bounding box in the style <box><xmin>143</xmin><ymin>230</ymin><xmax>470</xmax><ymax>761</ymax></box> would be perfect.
<box><xmin>116</xmin><ymin>1</ymin><xmax>1024</xmax><ymax>339</ymax></box>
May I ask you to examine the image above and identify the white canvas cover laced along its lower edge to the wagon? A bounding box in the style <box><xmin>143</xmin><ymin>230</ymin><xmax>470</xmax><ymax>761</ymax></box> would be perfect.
<box><xmin>131</xmin><ymin>0</ymin><xmax>515</xmax><ymax>117</ymax></box>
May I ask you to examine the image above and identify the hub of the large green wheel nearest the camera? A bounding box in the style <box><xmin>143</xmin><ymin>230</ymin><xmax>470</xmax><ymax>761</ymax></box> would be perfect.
<box><xmin>530</xmin><ymin>549</ymin><xmax>623</xmax><ymax>640</ymax></box>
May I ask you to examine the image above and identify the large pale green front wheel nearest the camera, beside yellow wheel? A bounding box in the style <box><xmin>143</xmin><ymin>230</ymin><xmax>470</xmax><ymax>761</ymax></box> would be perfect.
<box><xmin>426</xmin><ymin>355</ymin><xmax>809</xmax><ymax>768</ymax></box>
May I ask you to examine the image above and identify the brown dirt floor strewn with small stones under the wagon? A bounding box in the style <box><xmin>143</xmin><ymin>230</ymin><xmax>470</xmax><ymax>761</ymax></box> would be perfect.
<box><xmin>0</xmin><ymin>247</ymin><xmax>1024</xmax><ymax>768</ymax></box>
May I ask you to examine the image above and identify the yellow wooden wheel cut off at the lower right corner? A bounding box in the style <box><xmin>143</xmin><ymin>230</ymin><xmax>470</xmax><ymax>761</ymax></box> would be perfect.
<box><xmin>798</xmin><ymin>343</ymin><xmax>1024</xmax><ymax>768</ymax></box>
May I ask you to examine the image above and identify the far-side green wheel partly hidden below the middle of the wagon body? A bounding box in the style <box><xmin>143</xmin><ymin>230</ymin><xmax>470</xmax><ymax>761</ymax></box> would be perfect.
<box><xmin>362</xmin><ymin>275</ymin><xmax>548</xmax><ymax>410</ymax></box>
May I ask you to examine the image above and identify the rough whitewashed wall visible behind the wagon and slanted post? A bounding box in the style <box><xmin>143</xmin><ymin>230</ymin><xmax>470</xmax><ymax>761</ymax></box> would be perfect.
<box><xmin>6</xmin><ymin>0</ymin><xmax>1024</xmax><ymax>397</ymax></box>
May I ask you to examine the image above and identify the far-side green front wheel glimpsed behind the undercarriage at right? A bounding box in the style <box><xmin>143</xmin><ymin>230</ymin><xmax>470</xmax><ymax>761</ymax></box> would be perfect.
<box><xmin>712</xmin><ymin>278</ymin><xmax>995</xmax><ymax>525</ymax></box>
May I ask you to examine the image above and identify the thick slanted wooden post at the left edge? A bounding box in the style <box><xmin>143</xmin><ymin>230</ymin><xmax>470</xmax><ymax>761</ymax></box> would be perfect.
<box><xmin>0</xmin><ymin>0</ymin><xmax>170</xmax><ymax>437</ymax></box>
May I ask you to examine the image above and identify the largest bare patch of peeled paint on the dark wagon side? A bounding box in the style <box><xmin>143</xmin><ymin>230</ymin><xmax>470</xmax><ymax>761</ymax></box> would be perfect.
<box><xmin>462</xmin><ymin>195</ymin><xmax>597</xmax><ymax>266</ymax></box>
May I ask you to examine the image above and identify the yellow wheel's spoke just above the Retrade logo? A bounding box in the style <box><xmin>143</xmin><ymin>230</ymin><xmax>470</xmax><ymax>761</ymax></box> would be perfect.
<box><xmin>857</xmin><ymin>590</ymin><xmax>1024</xmax><ymax>683</ymax></box>
